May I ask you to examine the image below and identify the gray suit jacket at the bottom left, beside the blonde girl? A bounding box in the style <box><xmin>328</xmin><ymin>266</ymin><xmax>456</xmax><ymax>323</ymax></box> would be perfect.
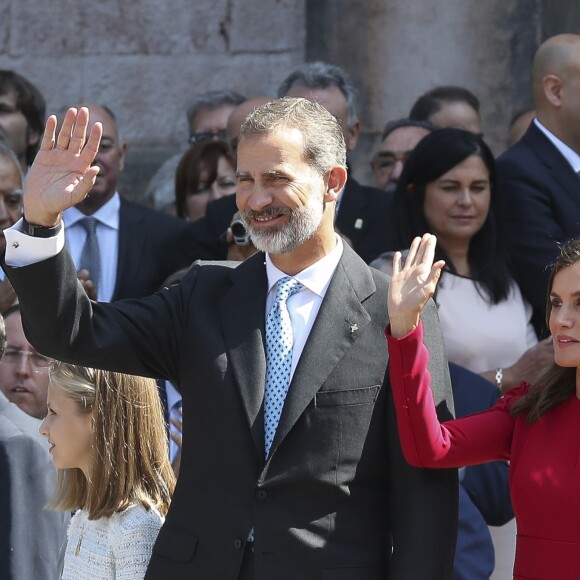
<box><xmin>0</xmin><ymin>393</ymin><xmax>68</xmax><ymax>580</ymax></box>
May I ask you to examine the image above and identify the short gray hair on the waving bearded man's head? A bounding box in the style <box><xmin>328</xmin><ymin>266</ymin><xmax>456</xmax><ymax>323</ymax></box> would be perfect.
<box><xmin>240</xmin><ymin>97</ymin><xmax>346</xmax><ymax>175</ymax></box>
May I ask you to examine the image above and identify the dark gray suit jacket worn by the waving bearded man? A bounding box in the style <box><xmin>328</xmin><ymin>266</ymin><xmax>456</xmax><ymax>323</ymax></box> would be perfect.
<box><xmin>7</xmin><ymin>246</ymin><xmax>457</xmax><ymax>580</ymax></box>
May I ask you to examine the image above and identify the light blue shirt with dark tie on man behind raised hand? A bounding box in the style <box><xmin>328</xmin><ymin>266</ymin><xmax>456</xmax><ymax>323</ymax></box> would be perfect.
<box><xmin>62</xmin><ymin>193</ymin><xmax>121</xmax><ymax>302</ymax></box>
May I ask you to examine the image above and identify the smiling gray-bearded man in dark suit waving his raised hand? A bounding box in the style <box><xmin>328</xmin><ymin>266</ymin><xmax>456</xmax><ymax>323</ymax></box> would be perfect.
<box><xmin>6</xmin><ymin>98</ymin><xmax>457</xmax><ymax>580</ymax></box>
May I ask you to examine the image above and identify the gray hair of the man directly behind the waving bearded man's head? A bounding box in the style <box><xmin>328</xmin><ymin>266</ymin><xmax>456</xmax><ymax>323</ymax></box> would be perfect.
<box><xmin>278</xmin><ymin>61</ymin><xmax>358</xmax><ymax>127</ymax></box>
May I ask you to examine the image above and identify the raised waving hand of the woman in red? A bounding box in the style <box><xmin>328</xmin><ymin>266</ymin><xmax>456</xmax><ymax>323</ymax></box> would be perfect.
<box><xmin>388</xmin><ymin>234</ymin><xmax>445</xmax><ymax>338</ymax></box>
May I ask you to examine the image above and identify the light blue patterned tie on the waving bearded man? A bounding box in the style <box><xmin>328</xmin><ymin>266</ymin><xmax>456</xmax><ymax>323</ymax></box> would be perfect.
<box><xmin>264</xmin><ymin>276</ymin><xmax>303</xmax><ymax>458</ymax></box>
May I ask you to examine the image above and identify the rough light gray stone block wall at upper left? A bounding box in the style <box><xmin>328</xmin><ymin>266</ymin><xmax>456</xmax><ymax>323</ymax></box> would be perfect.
<box><xmin>0</xmin><ymin>0</ymin><xmax>306</xmax><ymax>198</ymax></box>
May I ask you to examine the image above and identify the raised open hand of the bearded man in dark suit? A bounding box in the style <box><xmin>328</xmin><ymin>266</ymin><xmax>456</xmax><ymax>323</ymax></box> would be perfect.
<box><xmin>24</xmin><ymin>107</ymin><xmax>103</xmax><ymax>227</ymax></box>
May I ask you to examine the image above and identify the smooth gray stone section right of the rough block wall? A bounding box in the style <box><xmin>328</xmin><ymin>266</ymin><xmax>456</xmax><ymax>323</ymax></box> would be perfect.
<box><xmin>306</xmin><ymin>0</ymin><xmax>541</xmax><ymax>184</ymax></box>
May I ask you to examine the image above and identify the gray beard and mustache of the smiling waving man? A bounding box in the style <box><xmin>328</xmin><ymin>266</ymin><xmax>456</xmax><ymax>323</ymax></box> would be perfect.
<box><xmin>241</xmin><ymin>196</ymin><xmax>324</xmax><ymax>254</ymax></box>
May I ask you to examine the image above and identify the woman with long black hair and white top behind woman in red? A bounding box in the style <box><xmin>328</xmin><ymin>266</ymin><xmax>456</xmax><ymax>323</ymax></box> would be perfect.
<box><xmin>372</xmin><ymin>128</ymin><xmax>553</xmax><ymax>392</ymax></box>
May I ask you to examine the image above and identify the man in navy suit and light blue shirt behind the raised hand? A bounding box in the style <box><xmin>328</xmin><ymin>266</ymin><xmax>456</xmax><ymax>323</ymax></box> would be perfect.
<box><xmin>63</xmin><ymin>104</ymin><xmax>194</xmax><ymax>302</ymax></box>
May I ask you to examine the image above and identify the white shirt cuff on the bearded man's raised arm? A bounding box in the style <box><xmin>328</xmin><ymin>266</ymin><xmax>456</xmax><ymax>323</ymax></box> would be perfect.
<box><xmin>4</xmin><ymin>219</ymin><xmax>65</xmax><ymax>268</ymax></box>
